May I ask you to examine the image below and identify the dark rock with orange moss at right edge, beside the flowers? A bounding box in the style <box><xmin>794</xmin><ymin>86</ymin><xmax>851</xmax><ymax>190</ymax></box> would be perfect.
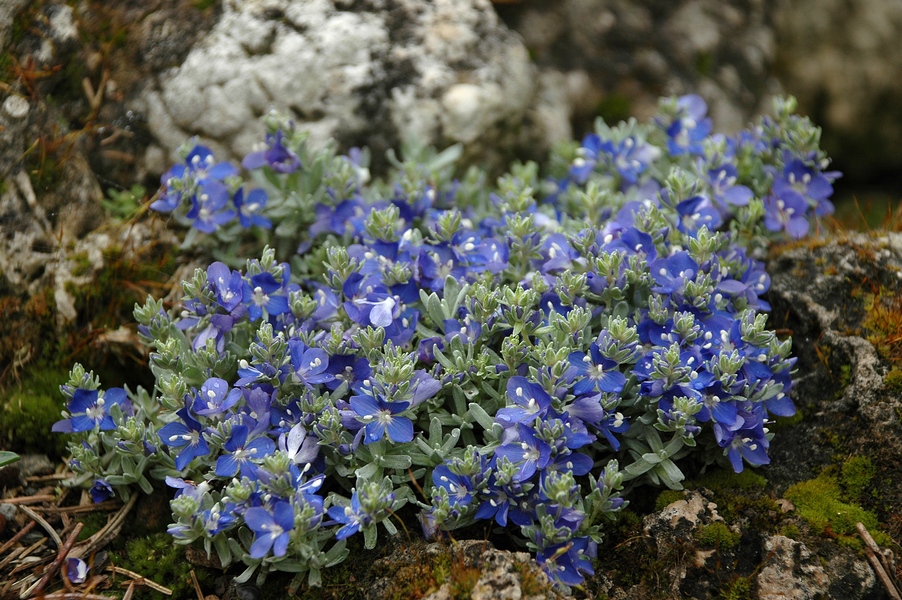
<box><xmin>764</xmin><ymin>233</ymin><xmax>902</xmax><ymax>500</ymax></box>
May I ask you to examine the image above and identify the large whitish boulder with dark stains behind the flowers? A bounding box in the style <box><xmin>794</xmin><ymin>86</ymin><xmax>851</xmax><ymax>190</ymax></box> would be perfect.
<box><xmin>134</xmin><ymin>0</ymin><xmax>569</xmax><ymax>173</ymax></box>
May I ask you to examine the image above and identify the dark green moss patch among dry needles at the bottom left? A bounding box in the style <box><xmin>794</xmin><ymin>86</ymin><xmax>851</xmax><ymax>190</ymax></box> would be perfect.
<box><xmin>113</xmin><ymin>533</ymin><xmax>213</xmax><ymax>598</ymax></box>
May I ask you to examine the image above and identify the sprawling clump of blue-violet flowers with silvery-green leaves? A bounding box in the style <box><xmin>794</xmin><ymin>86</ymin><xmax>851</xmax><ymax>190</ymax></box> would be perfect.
<box><xmin>54</xmin><ymin>96</ymin><xmax>837</xmax><ymax>587</ymax></box>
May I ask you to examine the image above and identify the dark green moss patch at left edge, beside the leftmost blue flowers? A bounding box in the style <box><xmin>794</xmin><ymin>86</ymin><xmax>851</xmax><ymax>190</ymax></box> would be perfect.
<box><xmin>0</xmin><ymin>368</ymin><xmax>68</xmax><ymax>457</ymax></box>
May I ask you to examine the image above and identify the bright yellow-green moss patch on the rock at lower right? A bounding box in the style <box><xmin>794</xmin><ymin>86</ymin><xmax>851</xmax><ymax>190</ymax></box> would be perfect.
<box><xmin>784</xmin><ymin>474</ymin><xmax>890</xmax><ymax>547</ymax></box>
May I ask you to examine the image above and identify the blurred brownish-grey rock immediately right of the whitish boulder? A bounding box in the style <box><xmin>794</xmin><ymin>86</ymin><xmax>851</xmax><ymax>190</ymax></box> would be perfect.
<box><xmin>498</xmin><ymin>0</ymin><xmax>780</xmax><ymax>131</ymax></box>
